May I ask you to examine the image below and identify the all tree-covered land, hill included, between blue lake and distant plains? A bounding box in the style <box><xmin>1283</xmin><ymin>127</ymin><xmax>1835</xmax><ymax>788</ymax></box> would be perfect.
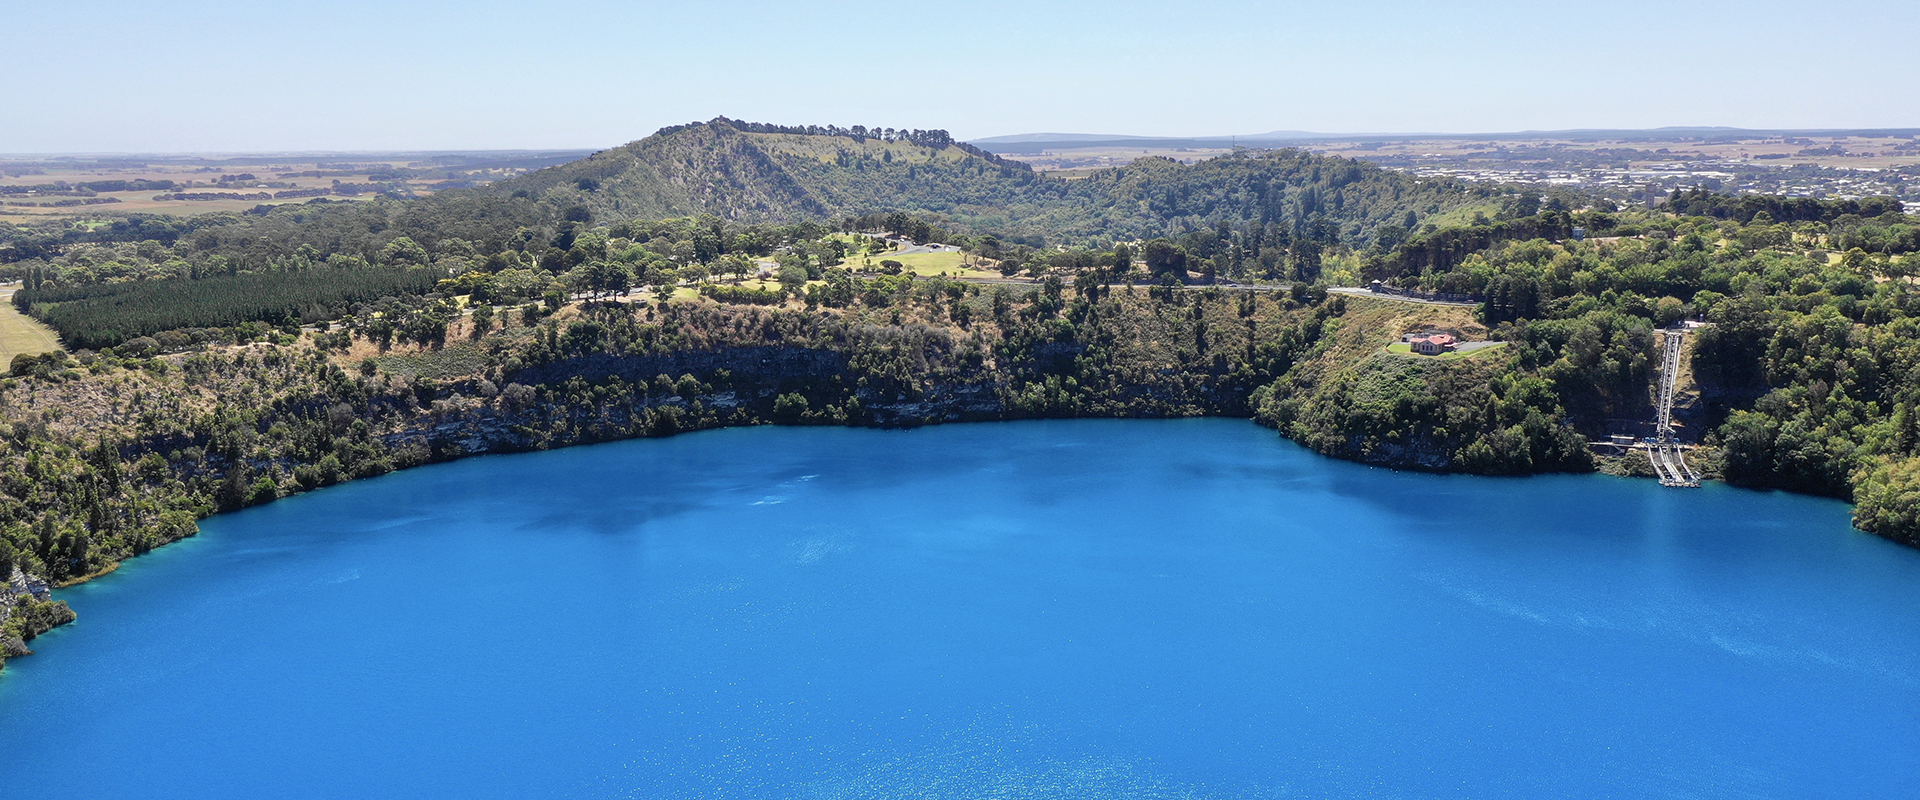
<box><xmin>0</xmin><ymin>121</ymin><xmax>1920</xmax><ymax>663</ymax></box>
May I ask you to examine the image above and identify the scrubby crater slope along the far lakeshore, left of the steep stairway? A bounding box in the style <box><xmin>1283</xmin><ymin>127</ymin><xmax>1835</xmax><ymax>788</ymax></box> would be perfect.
<box><xmin>0</xmin><ymin>288</ymin><xmax>1889</xmax><ymax>675</ymax></box>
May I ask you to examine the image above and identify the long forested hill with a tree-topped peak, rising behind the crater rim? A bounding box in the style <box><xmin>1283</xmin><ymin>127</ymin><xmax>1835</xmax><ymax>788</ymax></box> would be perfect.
<box><xmin>472</xmin><ymin>117</ymin><xmax>1486</xmax><ymax>246</ymax></box>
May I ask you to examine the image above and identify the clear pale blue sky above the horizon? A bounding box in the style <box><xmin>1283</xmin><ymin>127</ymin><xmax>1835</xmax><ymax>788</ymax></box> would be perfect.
<box><xmin>0</xmin><ymin>0</ymin><xmax>1920</xmax><ymax>153</ymax></box>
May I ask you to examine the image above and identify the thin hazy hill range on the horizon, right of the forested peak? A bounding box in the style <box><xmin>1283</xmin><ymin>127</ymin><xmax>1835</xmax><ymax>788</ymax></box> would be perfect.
<box><xmin>970</xmin><ymin>127</ymin><xmax>1920</xmax><ymax>155</ymax></box>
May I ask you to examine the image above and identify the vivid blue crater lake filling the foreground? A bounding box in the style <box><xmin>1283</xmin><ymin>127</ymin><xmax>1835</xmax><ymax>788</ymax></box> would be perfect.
<box><xmin>0</xmin><ymin>420</ymin><xmax>1920</xmax><ymax>800</ymax></box>
